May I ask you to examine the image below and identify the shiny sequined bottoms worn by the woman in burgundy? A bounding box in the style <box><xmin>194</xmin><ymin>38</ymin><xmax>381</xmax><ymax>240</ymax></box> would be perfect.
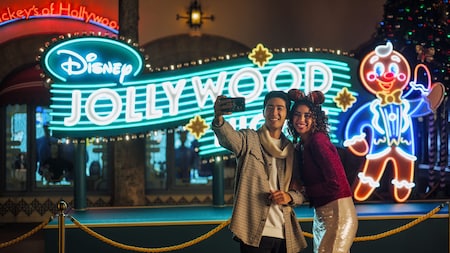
<box><xmin>313</xmin><ymin>197</ymin><xmax>358</xmax><ymax>253</ymax></box>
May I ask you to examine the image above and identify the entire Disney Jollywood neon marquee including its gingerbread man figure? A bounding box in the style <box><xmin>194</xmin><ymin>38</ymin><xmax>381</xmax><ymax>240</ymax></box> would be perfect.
<box><xmin>41</xmin><ymin>37</ymin><xmax>444</xmax><ymax>202</ymax></box>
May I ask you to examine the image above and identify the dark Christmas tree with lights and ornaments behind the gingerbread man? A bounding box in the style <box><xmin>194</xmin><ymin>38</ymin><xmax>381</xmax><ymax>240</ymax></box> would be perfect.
<box><xmin>355</xmin><ymin>0</ymin><xmax>450</xmax><ymax>90</ymax></box>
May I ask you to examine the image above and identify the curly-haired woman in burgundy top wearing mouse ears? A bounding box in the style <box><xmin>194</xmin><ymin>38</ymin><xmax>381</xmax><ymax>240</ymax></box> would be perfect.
<box><xmin>288</xmin><ymin>89</ymin><xmax>358</xmax><ymax>253</ymax></box>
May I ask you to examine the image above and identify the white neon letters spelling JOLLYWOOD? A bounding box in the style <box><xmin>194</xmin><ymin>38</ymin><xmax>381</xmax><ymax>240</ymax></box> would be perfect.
<box><xmin>64</xmin><ymin>62</ymin><xmax>333</xmax><ymax>126</ymax></box>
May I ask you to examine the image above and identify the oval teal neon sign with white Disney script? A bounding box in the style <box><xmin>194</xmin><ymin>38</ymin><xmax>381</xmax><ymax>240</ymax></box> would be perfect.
<box><xmin>44</xmin><ymin>37</ymin><xmax>143</xmax><ymax>83</ymax></box>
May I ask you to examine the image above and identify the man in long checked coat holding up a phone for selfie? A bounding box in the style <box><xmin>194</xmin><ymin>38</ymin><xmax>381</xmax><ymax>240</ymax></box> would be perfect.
<box><xmin>212</xmin><ymin>91</ymin><xmax>306</xmax><ymax>253</ymax></box>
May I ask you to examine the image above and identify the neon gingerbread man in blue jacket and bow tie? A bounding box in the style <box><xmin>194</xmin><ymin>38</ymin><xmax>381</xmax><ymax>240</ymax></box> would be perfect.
<box><xmin>344</xmin><ymin>42</ymin><xmax>444</xmax><ymax>202</ymax></box>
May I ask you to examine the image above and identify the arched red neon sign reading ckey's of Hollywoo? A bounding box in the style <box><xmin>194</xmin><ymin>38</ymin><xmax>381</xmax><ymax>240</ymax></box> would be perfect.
<box><xmin>0</xmin><ymin>2</ymin><xmax>119</xmax><ymax>33</ymax></box>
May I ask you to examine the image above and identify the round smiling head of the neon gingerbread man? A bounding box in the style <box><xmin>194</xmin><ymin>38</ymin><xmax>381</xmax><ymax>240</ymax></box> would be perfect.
<box><xmin>359</xmin><ymin>42</ymin><xmax>411</xmax><ymax>94</ymax></box>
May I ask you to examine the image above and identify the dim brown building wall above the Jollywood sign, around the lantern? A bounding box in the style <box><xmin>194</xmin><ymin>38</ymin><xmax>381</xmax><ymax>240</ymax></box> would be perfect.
<box><xmin>139</xmin><ymin>0</ymin><xmax>385</xmax><ymax>51</ymax></box>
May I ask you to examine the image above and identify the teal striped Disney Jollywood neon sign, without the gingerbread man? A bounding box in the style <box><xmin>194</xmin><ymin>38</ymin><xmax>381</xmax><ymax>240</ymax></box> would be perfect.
<box><xmin>41</xmin><ymin>37</ymin><xmax>358</xmax><ymax>156</ymax></box>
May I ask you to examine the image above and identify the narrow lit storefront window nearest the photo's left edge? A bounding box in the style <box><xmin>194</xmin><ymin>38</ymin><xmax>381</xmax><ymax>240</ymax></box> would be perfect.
<box><xmin>5</xmin><ymin>105</ymin><xmax>30</xmax><ymax>191</ymax></box>
